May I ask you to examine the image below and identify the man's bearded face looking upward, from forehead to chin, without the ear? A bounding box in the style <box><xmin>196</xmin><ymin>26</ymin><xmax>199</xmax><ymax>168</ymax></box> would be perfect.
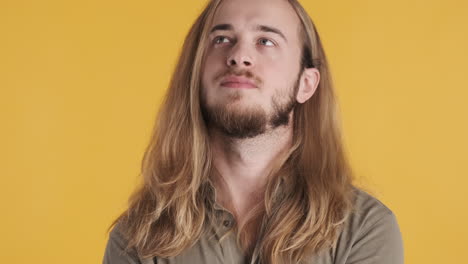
<box><xmin>201</xmin><ymin>0</ymin><xmax>302</xmax><ymax>138</ymax></box>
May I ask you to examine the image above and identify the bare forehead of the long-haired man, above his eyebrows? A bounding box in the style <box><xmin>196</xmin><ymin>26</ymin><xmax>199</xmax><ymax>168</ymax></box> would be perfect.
<box><xmin>211</xmin><ymin>0</ymin><xmax>299</xmax><ymax>34</ymax></box>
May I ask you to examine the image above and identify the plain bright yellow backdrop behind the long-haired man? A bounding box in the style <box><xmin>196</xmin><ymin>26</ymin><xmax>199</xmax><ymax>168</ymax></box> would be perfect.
<box><xmin>0</xmin><ymin>0</ymin><xmax>468</xmax><ymax>264</ymax></box>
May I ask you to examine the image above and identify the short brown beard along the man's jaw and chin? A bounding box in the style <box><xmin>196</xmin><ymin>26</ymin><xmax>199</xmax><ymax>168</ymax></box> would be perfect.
<box><xmin>201</xmin><ymin>78</ymin><xmax>299</xmax><ymax>139</ymax></box>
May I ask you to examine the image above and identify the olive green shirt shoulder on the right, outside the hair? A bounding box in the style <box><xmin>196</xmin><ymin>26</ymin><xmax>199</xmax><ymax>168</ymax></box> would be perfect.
<box><xmin>332</xmin><ymin>187</ymin><xmax>403</xmax><ymax>264</ymax></box>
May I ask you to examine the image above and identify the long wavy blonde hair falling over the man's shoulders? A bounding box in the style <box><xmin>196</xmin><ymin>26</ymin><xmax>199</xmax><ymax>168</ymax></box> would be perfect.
<box><xmin>110</xmin><ymin>0</ymin><xmax>354</xmax><ymax>264</ymax></box>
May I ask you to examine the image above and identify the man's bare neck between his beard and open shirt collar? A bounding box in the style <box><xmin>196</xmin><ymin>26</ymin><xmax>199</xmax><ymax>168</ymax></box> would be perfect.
<box><xmin>210</xmin><ymin>126</ymin><xmax>292</xmax><ymax>225</ymax></box>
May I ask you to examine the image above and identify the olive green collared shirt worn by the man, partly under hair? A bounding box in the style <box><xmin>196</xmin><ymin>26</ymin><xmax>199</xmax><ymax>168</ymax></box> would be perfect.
<box><xmin>103</xmin><ymin>188</ymin><xmax>403</xmax><ymax>264</ymax></box>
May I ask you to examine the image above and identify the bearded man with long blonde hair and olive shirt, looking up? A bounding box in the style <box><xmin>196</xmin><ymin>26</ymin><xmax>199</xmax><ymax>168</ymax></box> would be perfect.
<box><xmin>104</xmin><ymin>0</ymin><xmax>403</xmax><ymax>264</ymax></box>
